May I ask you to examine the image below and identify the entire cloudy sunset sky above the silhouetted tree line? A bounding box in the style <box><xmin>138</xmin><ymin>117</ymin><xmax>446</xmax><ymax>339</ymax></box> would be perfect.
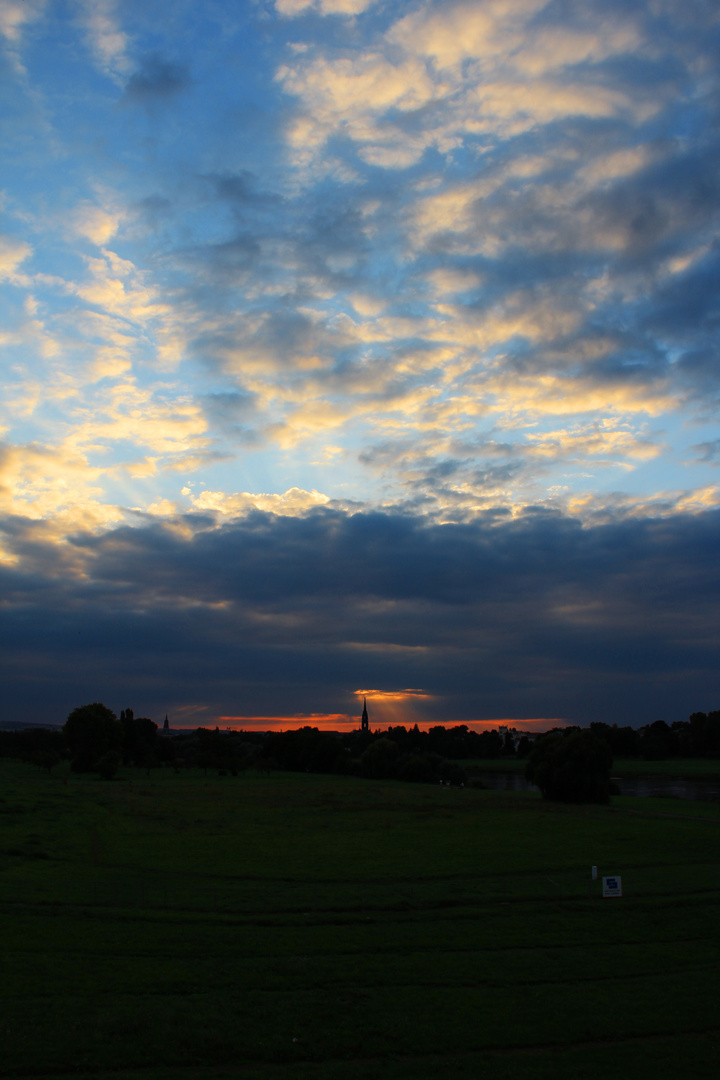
<box><xmin>0</xmin><ymin>0</ymin><xmax>720</xmax><ymax>728</ymax></box>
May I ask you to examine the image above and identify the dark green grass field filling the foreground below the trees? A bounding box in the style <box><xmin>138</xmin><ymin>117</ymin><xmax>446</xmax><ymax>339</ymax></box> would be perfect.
<box><xmin>0</xmin><ymin>762</ymin><xmax>720</xmax><ymax>1080</ymax></box>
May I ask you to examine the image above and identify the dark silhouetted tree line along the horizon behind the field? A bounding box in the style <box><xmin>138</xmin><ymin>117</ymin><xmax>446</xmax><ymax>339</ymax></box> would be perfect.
<box><xmin>0</xmin><ymin>702</ymin><xmax>720</xmax><ymax>802</ymax></box>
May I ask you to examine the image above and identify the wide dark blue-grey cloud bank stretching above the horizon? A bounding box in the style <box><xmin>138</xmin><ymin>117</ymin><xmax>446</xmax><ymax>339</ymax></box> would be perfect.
<box><xmin>0</xmin><ymin>510</ymin><xmax>720</xmax><ymax>724</ymax></box>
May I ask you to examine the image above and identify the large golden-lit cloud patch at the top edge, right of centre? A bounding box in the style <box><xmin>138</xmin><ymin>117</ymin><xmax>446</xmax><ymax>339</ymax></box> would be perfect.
<box><xmin>277</xmin><ymin>0</ymin><xmax>657</xmax><ymax>177</ymax></box>
